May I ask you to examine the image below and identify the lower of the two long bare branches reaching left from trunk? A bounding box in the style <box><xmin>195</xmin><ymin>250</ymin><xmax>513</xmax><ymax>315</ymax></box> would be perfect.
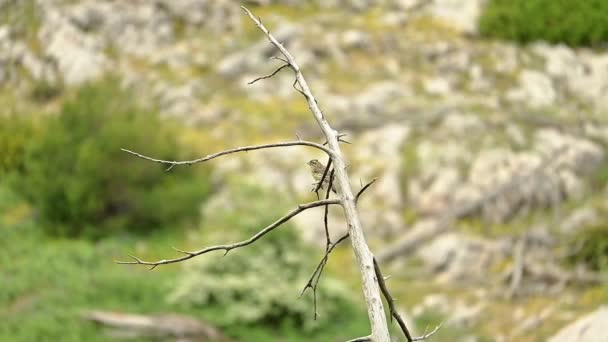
<box><xmin>116</xmin><ymin>199</ymin><xmax>340</xmax><ymax>269</ymax></box>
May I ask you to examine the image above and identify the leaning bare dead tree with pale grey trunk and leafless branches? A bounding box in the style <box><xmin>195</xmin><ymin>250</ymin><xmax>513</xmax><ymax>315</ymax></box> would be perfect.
<box><xmin>118</xmin><ymin>7</ymin><xmax>439</xmax><ymax>342</ymax></box>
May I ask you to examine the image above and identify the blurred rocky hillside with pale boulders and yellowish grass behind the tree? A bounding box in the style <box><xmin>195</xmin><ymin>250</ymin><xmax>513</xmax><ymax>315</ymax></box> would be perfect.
<box><xmin>0</xmin><ymin>0</ymin><xmax>608</xmax><ymax>341</ymax></box>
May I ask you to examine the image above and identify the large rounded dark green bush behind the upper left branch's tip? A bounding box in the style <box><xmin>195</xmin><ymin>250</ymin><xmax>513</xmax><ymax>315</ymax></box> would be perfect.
<box><xmin>15</xmin><ymin>80</ymin><xmax>209</xmax><ymax>238</ymax></box>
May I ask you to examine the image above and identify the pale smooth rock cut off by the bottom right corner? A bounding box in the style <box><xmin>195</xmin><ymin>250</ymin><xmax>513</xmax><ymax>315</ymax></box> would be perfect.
<box><xmin>547</xmin><ymin>306</ymin><xmax>608</xmax><ymax>342</ymax></box>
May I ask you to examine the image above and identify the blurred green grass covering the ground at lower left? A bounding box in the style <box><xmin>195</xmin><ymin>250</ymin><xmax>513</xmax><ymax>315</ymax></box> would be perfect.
<box><xmin>0</xmin><ymin>186</ymin><xmax>368</xmax><ymax>342</ymax></box>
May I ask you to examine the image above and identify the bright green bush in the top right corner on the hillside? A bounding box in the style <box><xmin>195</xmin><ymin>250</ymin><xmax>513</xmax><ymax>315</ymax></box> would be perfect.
<box><xmin>479</xmin><ymin>0</ymin><xmax>608</xmax><ymax>46</ymax></box>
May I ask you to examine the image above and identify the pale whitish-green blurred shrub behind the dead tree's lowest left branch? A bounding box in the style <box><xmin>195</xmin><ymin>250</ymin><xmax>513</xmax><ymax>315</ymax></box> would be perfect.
<box><xmin>171</xmin><ymin>186</ymin><xmax>354</xmax><ymax>332</ymax></box>
